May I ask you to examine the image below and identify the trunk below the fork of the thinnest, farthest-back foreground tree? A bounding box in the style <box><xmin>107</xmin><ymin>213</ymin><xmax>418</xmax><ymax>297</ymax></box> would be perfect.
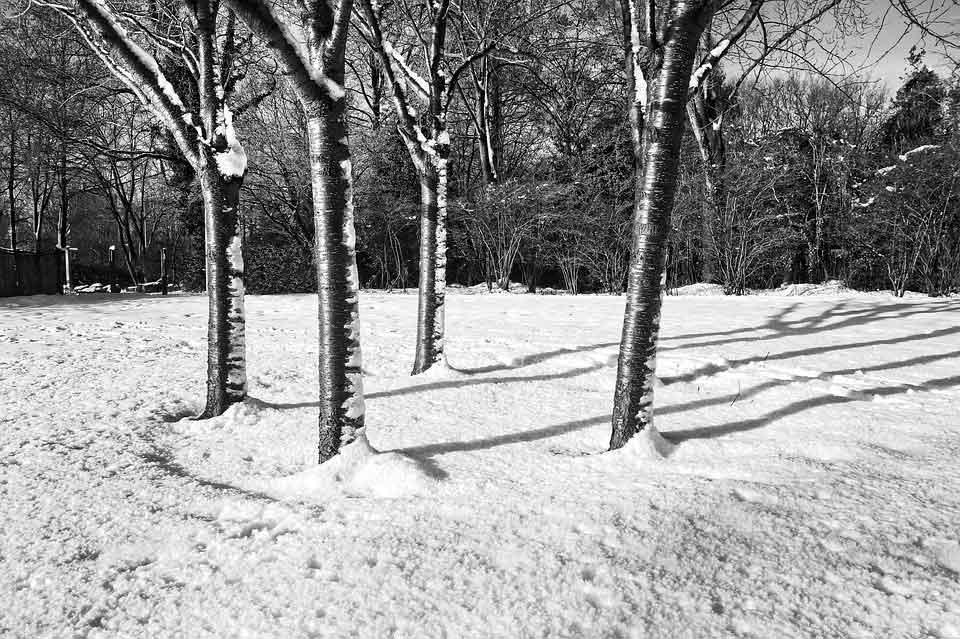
<box><xmin>412</xmin><ymin>156</ymin><xmax>447</xmax><ymax>375</ymax></box>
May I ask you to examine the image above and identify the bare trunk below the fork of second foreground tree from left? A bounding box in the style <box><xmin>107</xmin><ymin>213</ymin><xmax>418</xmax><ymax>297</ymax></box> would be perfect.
<box><xmin>307</xmin><ymin>100</ymin><xmax>364</xmax><ymax>463</ymax></box>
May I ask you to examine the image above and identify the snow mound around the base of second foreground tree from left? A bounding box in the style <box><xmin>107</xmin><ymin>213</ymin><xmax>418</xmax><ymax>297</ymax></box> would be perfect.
<box><xmin>265</xmin><ymin>433</ymin><xmax>436</xmax><ymax>500</ymax></box>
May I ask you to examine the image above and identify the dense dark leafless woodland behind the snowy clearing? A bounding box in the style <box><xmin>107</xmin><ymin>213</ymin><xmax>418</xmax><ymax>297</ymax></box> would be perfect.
<box><xmin>0</xmin><ymin>2</ymin><xmax>960</xmax><ymax>295</ymax></box>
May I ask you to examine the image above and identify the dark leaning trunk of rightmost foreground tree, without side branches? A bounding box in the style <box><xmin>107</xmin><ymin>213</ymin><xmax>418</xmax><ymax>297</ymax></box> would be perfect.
<box><xmin>610</xmin><ymin>7</ymin><xmax>709</xmax><ymax>450</ymax></box>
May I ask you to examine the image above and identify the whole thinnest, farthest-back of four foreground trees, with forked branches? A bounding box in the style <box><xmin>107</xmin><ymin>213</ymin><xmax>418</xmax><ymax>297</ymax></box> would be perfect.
<box><xmin>360</xmin><ymin>0</ymin><xmax>493</xmax><ymax>375</ymax></box>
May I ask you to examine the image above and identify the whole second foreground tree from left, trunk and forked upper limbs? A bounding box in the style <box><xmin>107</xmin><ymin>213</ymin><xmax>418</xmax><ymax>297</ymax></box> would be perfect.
<box><xmin>226</xmin><ymin>0</ymin><xmax>364</xmax><ymax>463</ymax></box>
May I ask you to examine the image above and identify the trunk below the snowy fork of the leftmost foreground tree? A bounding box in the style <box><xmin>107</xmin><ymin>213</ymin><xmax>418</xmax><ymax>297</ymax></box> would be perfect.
<box><xmin>200</xmin><ymin>162</ymin><xmax>247</xmax><ymax>419</ymax></box>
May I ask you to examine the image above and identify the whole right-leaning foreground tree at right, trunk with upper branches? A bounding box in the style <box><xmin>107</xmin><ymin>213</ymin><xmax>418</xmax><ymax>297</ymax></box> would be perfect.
<box><xmin>610</xmin><ymin>0</ymin><xmax>763</xmax><ymax>450</ymax></box>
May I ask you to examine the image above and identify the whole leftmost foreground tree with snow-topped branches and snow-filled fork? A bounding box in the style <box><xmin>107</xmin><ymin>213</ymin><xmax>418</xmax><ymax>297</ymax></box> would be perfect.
<box><xmin>37</xmin><ymin>0</ymin><xmax>247</xmax><ymax>418</ymax></box>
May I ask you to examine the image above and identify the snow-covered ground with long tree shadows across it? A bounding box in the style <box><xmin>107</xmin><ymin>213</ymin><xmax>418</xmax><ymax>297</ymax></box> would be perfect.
<box><xmin>0</xmin><ymin>293</ymin><xmax>960</xmax><ymax>639</ymax></box>
